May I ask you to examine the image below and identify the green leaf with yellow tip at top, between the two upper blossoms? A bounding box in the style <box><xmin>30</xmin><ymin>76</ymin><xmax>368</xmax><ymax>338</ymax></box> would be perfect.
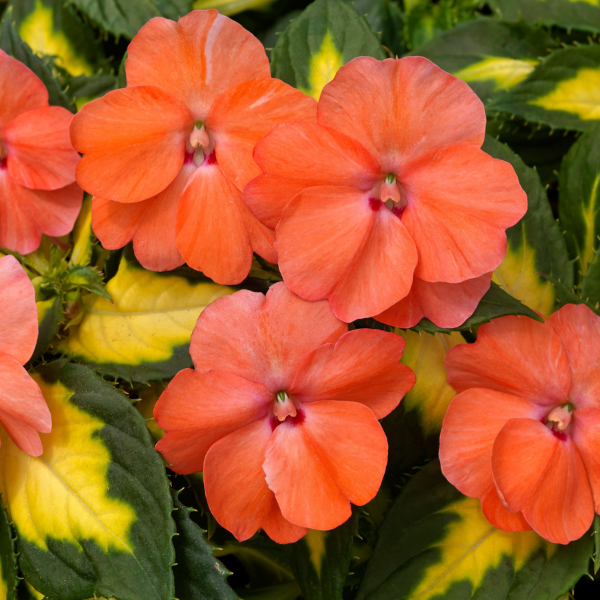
<box><xmin>271</xmin><ymin>0</ymin><xmax>385</xmax><ymax>100</ymax></box>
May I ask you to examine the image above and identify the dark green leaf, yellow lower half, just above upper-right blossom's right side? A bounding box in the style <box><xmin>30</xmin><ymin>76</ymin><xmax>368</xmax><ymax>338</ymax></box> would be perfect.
<box><xmin>418</xmin><ymin>18</ymin><xmax>555</xmax><ymax>102</ymax></box>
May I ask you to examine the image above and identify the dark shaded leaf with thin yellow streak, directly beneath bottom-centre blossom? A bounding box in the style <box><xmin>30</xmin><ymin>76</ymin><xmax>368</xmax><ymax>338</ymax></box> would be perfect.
<box><xmin>290</xmin><ymin>513</ymin><xmax>356</xmax><ymax>600</ymax></box>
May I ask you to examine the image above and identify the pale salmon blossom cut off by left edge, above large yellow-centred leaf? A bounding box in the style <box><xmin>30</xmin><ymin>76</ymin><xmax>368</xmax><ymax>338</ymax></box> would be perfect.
<box><xmin>0</xmin><ymin>256</ymin><xmax>52</xmax><ymax>456</ymax></box>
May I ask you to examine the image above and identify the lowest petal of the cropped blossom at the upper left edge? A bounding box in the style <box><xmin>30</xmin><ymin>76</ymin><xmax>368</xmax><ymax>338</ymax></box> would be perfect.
<box><xmin>0</xmin><ymin>175</ymin><xmax>83</xmax><ymax>254</ymax></box>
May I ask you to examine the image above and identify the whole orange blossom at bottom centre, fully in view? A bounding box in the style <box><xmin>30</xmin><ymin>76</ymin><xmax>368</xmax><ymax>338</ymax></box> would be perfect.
<box><xmin>154</xmin><ymin>283</ymin><xmax>415</xmax><ymax>543</ymax></box>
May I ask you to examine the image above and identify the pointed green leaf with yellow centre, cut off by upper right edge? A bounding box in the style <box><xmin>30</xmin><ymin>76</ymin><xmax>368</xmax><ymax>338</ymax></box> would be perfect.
<box><xmin>488</xmin><ymin>44</ymin><xmax>600</xmax><ymax>131</ymax></box>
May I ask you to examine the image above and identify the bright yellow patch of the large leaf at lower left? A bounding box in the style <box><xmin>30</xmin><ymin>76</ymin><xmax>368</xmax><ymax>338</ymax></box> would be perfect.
<box><xmin>0</xmin><ymin>374</ymin><xmax>137</xmax><ymax>553</ymax></box>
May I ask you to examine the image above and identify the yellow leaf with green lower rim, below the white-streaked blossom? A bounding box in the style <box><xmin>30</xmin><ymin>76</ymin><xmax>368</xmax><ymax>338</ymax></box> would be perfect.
<box><xmin>59</xmin><ymin>252</ymin><xmax>234</xmax><ymax>383</ymax></box>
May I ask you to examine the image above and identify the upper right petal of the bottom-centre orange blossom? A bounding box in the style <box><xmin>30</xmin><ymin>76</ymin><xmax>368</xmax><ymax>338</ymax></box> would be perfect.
<box><xmin>289</xmin><ymin>329</ymin><xmax>415</xmax><ymax>419</ymax></box>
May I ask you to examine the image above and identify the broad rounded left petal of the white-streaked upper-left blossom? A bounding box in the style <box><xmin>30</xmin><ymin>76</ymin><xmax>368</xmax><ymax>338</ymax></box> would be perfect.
<box><xmin>71</xmin><ymin>87</ymin><xmax>193</xmax><ymax>202</ymax></box>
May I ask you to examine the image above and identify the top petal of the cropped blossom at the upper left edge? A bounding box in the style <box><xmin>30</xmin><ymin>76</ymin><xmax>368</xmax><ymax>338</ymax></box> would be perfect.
<box><xmin>0</xmin><ymin>50</ymin><xmax>48</xmax><ymax>128</ymax></box>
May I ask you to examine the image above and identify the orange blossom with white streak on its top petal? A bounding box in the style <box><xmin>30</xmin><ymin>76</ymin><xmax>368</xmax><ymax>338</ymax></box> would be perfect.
<box><xmin>71</xmin><ymin>10</ymin><xmax>316</xmax><ymax>284</ymax></box>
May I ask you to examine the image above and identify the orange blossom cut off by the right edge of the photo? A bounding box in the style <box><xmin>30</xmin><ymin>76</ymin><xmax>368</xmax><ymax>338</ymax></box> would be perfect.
<box><xmin>440</xmin><ymin>305</ymin><xmax>600</xmax><ymax>544</ymax></box>
